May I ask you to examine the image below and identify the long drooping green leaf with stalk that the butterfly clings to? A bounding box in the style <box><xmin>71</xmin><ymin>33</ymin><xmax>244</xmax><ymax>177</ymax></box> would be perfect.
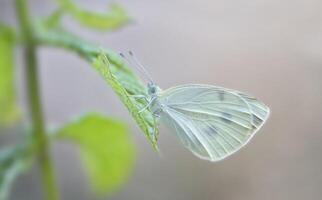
<box><xmin>36</xmin><ymin>23</ymin><xmax>159</xmax><ymax>149</ymax></box>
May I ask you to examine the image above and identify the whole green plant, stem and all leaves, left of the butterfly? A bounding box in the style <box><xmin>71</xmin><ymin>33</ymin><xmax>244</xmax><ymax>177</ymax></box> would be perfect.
<box><xmin>0</xmin><ymin>0</ymin><xmax>158</xmax><ymax>200</ymax></box>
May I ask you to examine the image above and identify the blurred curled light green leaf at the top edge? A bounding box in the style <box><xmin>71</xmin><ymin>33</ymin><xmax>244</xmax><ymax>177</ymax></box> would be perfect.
<box><xmin>57</xmin><ymin>0</ymin><xmax>130</xmax><ymax>31</ymax></box>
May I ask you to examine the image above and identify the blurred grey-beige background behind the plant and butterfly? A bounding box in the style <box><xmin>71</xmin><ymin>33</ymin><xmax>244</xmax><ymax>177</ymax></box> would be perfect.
<box><xmin>0</xmin><ymin>0</ymin><xmax>322</xmax><ymax>200</ymax></box>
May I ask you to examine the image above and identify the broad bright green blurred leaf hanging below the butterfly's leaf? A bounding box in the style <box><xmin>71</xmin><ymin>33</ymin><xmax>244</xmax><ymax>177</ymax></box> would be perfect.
<box><xmin>56</xmin><ymin>114</ymin><xmax>134</xmax><ymax>193</ymax></box>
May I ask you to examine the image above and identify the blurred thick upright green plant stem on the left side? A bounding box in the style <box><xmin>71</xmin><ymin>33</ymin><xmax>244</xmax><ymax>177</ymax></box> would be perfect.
<box><xmin>15</xmin><ymin>0</ymin><xmax>59</xmax><ymax>200</ymax></box>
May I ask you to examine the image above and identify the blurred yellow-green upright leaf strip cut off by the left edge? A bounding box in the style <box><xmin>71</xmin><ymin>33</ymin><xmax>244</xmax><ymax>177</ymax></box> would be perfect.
<box><xmin>0</xmin><ymin>24</ymin><xmax>19</xmax><ymax>127</ymax></box>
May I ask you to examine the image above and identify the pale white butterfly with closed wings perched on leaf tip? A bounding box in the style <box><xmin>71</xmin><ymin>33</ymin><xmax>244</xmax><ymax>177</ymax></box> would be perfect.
<box><xmin>120</xmin><ymin>51</ymin><xmax>270</xmax><ymax>161</ymax></box>
